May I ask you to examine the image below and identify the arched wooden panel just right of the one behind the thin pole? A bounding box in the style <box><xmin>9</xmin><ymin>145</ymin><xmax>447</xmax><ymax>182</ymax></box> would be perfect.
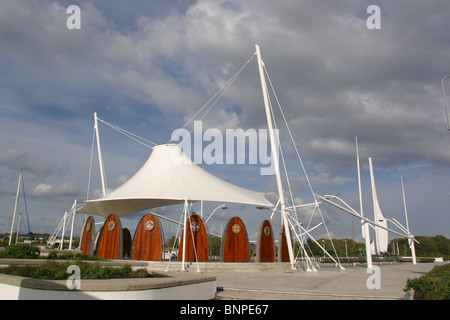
<box><xmin>222</xmin><ymin>217</ymin><xmax>249</xmax><ymax>262</ymax></box>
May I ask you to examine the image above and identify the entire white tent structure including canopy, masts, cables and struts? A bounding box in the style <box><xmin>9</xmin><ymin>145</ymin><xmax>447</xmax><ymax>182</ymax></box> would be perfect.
<box><xmin>77</xmin><ymin>45</ymin><xmax>345</xmax><ymax>271</ymax></box>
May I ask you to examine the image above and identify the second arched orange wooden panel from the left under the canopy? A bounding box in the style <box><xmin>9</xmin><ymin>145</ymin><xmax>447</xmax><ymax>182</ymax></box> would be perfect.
<box><xmin>97</xmin><ymin>214</ymin><xmax>123</xmax><ymax>259</ymax></box>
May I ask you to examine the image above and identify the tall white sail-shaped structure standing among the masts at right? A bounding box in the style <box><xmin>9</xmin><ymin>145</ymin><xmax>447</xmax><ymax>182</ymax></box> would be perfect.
<box><xmin>369</xmin><ymin>158</ymin><xmax>389</xmax><ymax>254</ymax></box>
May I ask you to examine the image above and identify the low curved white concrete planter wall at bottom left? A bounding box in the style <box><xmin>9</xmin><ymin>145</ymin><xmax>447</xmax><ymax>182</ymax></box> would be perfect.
<box><xmin>0</xmin><ymin>273</ymin><xmax>217</xmax><ymax>300</ymax></box>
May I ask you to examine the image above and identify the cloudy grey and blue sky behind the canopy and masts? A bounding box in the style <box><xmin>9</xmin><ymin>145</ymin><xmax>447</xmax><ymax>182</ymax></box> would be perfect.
<box><xmin>0</xmin><ymin>0</ymin><xmax>450</xmax><ymax>245</ymax></box>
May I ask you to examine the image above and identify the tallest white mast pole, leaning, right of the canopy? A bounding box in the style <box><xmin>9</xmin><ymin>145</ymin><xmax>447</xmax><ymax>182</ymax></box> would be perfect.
<box><xmin>255</xmin><ymin>44</ymin><xmax>295</xmax><ymax>269</ymax></box>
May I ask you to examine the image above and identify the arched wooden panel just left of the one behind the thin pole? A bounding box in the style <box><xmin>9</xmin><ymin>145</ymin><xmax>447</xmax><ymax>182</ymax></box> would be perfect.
<box><xmin>132</xmin><ymin>213</ymin><xmax>162</xmax><ymax>261</ymax></box>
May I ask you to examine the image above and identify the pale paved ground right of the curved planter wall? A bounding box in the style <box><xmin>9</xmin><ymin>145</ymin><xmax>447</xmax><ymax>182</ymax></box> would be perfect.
<box><xmin>211</xmin><ymin>263</ymin><xmax>442</xmax><ymax>300</ymax></box>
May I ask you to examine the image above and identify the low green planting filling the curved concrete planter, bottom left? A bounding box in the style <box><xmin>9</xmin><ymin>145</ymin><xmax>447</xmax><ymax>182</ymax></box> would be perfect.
<box><xmin>0</xmin><ymin>261</ymin><xmax>167</xmax><ymax>280</ymax></box>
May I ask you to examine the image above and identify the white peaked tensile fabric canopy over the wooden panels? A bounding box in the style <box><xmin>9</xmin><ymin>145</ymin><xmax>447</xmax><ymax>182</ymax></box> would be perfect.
<box><xmin>77</xmin><ymin>144</ymin><xmax>273</xmax><ymax>217</ymax></box>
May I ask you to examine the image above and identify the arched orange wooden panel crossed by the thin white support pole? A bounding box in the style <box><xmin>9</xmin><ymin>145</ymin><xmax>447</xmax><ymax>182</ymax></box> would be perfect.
<box><xmin>178</xmin><ymin>214</ymin><xmax>209</xmax><ymax>262</ymax></box>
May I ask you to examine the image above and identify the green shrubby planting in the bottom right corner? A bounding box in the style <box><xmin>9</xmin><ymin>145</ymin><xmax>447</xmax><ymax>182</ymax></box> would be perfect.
<box><xmin>405</xmin><ymin>263</ymin><xmax>450</xmax><ymax>300</ymax></box>
